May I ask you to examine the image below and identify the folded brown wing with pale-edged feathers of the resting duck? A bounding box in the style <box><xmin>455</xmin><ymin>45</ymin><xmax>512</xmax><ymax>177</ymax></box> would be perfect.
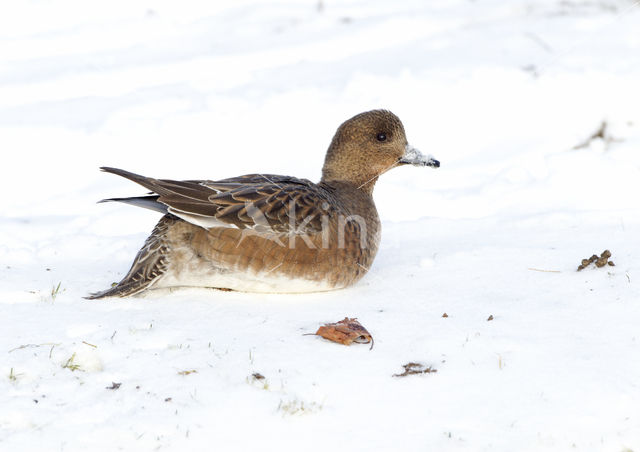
<box><xmin>100</xmin><ymin>167</ymin><xmax>337</xmax><ymax>234</ymax></box>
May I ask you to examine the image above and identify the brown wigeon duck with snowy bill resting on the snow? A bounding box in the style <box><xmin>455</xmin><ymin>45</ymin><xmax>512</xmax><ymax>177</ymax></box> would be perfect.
<box><xmin>88</xmin><ymin>110</ymin><xmax>440</xmax><ymax>299</ymax></box>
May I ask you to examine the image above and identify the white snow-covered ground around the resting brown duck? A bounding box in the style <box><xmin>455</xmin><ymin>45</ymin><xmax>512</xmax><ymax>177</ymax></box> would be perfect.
<box><xmin>0</xmin><ymin>0</ymin><xmax>640</xmax><ymax>452</ymax></box>
